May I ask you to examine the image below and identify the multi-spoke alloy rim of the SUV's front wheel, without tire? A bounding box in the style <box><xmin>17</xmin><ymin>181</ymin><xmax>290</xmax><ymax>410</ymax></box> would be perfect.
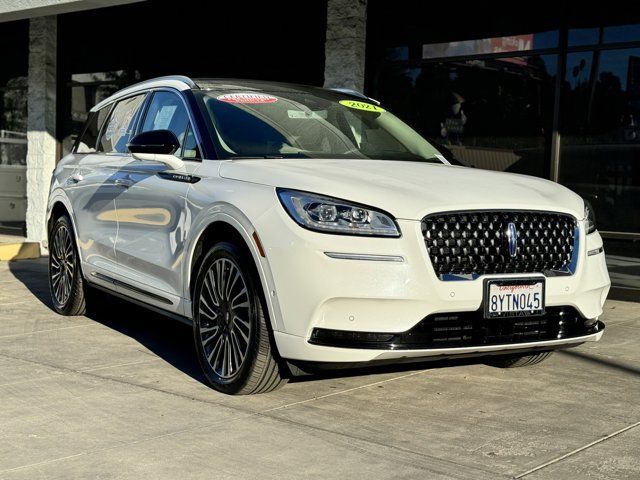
<box><xmin>198</xmin><ymin>258</ymin><xmax>253</xmax><ymax>381</ymax></box>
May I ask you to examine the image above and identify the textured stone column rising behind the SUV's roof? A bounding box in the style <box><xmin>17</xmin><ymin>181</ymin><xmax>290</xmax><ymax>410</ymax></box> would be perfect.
<box><xmin>324</xmin><ymin>0</ymin><xmax>367</xmax><ymax>92</ymax></box>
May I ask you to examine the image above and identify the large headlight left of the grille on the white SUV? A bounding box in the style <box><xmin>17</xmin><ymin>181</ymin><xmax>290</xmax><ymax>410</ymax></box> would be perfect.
<box><xmin>276</xmin><ymin>188</ymin><xmax>400</xmax><ymax>237</ymax></box>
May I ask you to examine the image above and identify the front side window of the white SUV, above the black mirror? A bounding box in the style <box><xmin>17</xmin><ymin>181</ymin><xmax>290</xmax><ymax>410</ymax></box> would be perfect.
<box><xmin>142</xmin><ymin>92</ymin><xmax>193</xmax><ymax>155</ymax></box>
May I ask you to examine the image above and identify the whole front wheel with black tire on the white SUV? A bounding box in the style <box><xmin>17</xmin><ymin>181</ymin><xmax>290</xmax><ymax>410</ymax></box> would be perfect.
<box><xmin>192</xmin><ymin>242</ymin><xmax>287</xmax><ymax>395</ymax></box>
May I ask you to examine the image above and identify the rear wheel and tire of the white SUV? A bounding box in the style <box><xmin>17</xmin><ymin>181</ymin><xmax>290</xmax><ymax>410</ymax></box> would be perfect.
<box><xmin>49</xmin><ymin>215</ymin><xmax>88</xmax><ymax>316</ymax></box>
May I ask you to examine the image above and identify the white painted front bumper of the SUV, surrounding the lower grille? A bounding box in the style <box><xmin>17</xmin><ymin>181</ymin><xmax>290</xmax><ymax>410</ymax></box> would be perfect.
<box><xmin>255</xmin><ymin>205</ymin><xmax>610</xmax><ymax>362</ymax></box>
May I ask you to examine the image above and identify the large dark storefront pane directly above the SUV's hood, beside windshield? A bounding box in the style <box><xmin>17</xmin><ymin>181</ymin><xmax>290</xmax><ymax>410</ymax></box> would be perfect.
<box><xmin>376</xmin><ymin>55</ymin><xmax>557</xmax><ymax>177</ymax></box>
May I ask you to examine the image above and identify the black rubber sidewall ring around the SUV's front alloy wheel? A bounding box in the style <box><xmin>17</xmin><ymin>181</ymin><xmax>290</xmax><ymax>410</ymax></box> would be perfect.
<box><xmin>192</xmin><ymin>242</ymin><xmax>264</xmax><ymax>394</ymax></box>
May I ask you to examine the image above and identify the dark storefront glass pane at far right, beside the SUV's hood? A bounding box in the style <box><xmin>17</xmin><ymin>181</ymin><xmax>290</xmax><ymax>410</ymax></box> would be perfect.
<box><xmin>560</xmin><ymin>48</ymin><xmax>640</xmax><ymax>233</ymax></box>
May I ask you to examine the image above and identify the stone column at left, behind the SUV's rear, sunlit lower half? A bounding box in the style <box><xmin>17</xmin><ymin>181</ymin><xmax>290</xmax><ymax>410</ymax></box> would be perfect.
<box><xmin>27</xmin><ymin>16</ymin><xmax>57</xmax><ymax>246</ymax></box>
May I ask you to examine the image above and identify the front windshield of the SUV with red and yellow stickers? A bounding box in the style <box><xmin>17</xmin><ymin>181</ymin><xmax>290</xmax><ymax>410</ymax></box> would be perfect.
<box><xmin>195</xmin><ymin>86</ymin><xmax>445</xmax><ymax>163</ymax></box>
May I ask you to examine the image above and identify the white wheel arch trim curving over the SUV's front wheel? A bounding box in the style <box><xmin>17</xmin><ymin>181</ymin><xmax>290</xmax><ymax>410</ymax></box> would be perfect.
<box><xmin>183</xmin><ymin>202</ymin><xmax>283</xmax><ymax>331</ymax></box>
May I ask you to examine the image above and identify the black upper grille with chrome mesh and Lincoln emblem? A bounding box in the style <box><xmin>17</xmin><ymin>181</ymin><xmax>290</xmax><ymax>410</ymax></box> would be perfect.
<box><xmin>422</xmin><ymin>211</ymin><xmax>577</xmax><ymax>280</ymax></box>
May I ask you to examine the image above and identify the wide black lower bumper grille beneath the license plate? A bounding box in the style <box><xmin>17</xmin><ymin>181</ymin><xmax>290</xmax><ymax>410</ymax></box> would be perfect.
<box><xmin>309</xmin><ymin>307</ymin><xmax>604</xmax><ymax>350</ymax></box>
